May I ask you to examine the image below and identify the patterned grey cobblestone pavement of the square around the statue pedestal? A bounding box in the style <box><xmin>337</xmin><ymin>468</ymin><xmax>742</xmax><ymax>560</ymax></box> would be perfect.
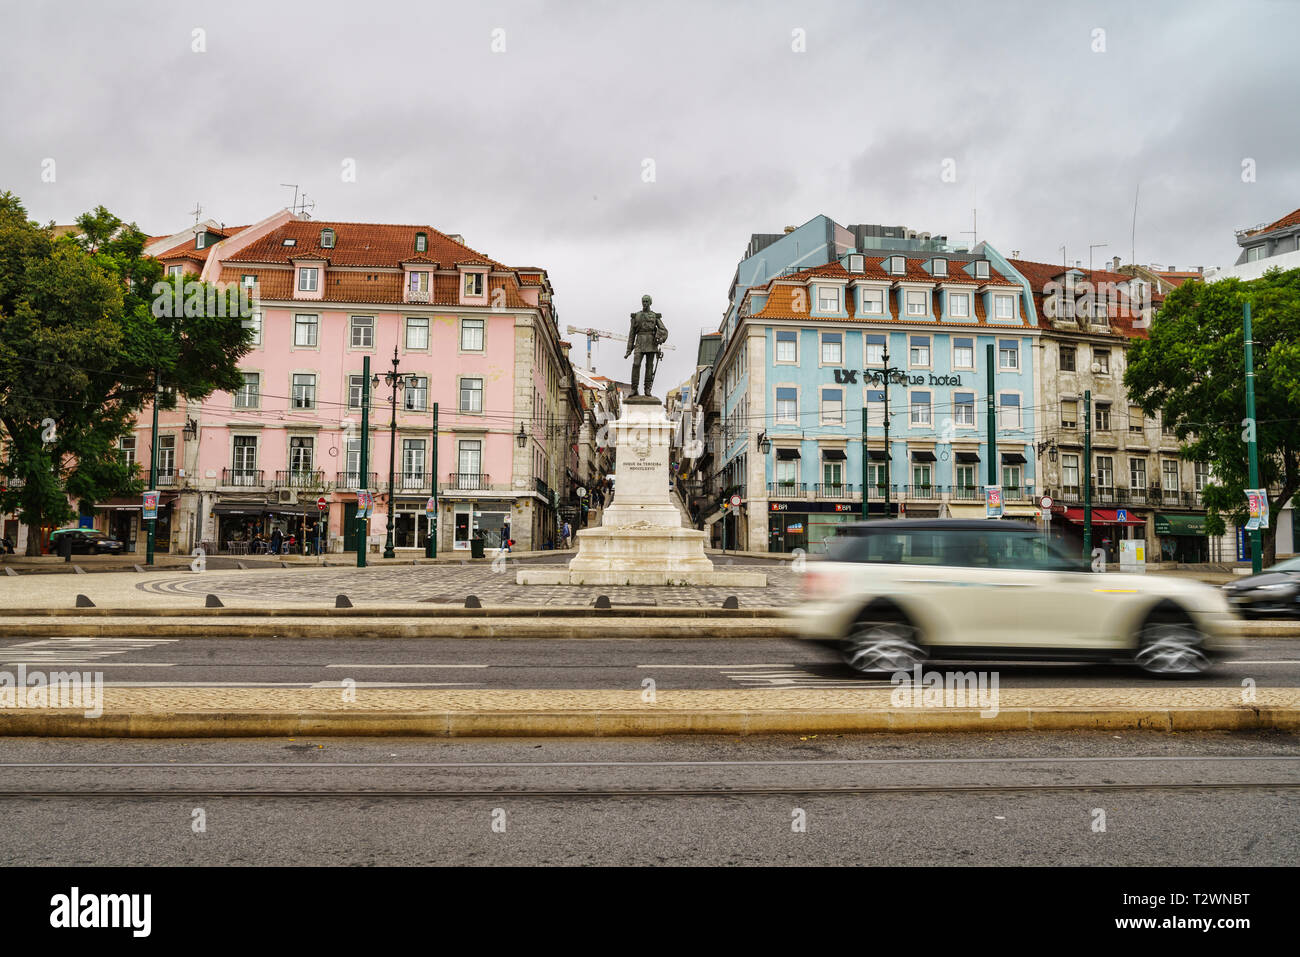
<box><xmin>135</xmin><ymin>560</ymin><xmax>800</xmax><ymax>607</ymax></box>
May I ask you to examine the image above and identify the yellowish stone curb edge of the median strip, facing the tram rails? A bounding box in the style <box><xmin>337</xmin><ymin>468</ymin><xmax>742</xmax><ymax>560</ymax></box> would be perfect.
<box><xmin>0</xmin><ymin>705</ymin><xmax>1300</xmax><ymax>737</ymax></box>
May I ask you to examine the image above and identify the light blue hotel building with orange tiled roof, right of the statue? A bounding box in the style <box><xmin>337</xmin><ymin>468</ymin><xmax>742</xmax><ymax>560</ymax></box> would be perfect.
<box><xmin>711</xmin><ymin>217</ymin><xmax>1037</xmax><ymax>551</ymax></box>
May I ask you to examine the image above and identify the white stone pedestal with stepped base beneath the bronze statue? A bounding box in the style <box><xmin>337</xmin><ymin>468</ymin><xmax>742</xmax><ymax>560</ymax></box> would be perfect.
<box><xmin>516</xmin><ymin>397</ymin><xmax>767</xmax><ymax>588</ymax></box>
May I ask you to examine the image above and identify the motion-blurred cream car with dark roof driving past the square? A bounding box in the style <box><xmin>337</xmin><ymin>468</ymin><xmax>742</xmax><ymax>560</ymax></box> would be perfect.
<box><xmin>794</xmin><ymin>519</ymin><xmax>1234</xmax><ymax>675</ymax></box>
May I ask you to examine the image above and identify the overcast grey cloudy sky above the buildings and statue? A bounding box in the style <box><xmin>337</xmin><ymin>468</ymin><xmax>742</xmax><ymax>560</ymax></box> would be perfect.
<box><xmin>0</xmin><ymin>0</ymin><xmax>1300</xmax><ymax>394</ymax></box>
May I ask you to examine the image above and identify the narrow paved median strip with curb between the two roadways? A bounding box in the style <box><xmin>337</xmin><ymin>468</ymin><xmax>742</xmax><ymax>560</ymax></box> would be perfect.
<box><xmin>0</xmin><ymin>684</ymin><xmax>1300</xmax><ymax>737</ymax></box>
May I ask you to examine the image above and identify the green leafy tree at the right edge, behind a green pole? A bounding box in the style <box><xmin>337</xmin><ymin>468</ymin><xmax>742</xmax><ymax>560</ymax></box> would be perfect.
<box><xmin>1125</xmin><ymin>269</ymin><xmax>1300</xmax><ymax>566</ymax></box>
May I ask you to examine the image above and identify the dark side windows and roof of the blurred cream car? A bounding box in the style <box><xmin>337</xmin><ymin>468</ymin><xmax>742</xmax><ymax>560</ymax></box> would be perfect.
<box><xmin>828</xmin><ymin>528</ymin><xmax>1087</xmax><ymax>571</ymax></box>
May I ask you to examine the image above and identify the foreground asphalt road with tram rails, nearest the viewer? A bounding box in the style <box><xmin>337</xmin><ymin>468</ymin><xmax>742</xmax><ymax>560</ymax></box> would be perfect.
<box><xmin>0</xmin><ymin>732</ymin><xmax>1300</xmax><ymax>866</ymax></box>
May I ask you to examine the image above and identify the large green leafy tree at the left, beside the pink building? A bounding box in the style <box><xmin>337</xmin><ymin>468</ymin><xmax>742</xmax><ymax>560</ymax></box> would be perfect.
<box><xmin>0</xmin><ymin>192</ymin><xmax>250</xmax><ymax>555</ymax></box>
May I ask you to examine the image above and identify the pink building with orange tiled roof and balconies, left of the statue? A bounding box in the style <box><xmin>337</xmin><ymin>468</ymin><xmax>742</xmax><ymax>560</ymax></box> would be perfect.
<box><xmin>104</xmin><ymin>211</ymin><xmax>580</xmax><ymax>554</ymax></box>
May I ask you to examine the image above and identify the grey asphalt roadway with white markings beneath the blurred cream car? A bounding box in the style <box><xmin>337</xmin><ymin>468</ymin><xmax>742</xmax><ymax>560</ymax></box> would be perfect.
<box><xmin>0</xmin><ymin>634</ymin><xmax>1300</xmax><ymax>690</ymax></box>
